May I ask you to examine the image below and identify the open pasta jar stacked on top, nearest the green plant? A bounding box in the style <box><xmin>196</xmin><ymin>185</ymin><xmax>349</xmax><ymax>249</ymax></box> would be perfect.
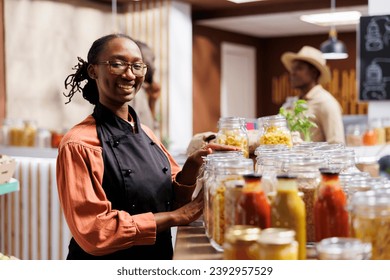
<box><xmin>260</xmin><ymin>115</ymin><xmax>292</xmax><ymax>147</ymax></box>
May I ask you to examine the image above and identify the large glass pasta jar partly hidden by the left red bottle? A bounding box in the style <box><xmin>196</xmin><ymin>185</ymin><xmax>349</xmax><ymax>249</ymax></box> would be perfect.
<box><xmin>209</xmin><ymin>158</ymin><xmax>253</xmax><ymax>251</ymax></box>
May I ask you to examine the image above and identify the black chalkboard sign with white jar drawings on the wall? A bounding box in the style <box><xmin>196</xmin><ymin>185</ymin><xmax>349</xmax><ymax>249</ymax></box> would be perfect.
<box><xmin>358</xmin><ymin>15</ymin><xmax>390</xmax><ymax>100</ymax></box>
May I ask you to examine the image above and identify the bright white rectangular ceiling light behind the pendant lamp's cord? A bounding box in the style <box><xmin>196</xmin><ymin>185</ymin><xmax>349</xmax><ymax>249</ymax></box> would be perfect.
<box><xmin>300</xmin><ymin>11</ymin><xmax>361</xmax><ymax>26</ymax></box>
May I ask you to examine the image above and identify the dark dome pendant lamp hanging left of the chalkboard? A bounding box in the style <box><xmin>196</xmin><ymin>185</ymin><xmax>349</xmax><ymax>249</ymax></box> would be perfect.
<box><xmin>320</xmin><ymin>0</ymin><xmax>348</xmax><ymax>60</ymax></box>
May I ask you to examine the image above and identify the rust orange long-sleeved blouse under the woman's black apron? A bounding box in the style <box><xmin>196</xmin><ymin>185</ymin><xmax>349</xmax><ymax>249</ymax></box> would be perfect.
<box><xmin>57</xmin><ymin>115</ymin><xmax>194</xmax><ymax>256</ymax></box>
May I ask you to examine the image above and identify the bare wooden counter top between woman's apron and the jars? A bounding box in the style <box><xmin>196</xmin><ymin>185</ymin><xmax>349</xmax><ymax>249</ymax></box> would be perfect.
<box><xmin>173</xmin><ymin>220</ymin><xmax>222</xmax><ymax>260</ymax></box>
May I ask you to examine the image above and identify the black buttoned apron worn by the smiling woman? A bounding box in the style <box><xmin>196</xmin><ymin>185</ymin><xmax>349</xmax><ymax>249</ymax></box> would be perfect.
<box><xmin>67</xmin><ymin>104</ymin><xmax>173</xmax><ymax>260</ymax></box>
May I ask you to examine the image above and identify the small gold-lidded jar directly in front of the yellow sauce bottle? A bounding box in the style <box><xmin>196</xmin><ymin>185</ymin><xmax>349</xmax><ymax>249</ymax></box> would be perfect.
<box><xmin>256</xmin><ymin>228</ymin><xmax>298</xmax><ymax>260</ymax></box>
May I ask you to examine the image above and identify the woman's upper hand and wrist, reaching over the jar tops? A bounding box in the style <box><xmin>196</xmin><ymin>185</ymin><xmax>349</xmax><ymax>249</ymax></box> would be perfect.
<box><xmin>176</xmin><ymin>143</ymin><xmax>241</xmax><ymax>185</ymax></box>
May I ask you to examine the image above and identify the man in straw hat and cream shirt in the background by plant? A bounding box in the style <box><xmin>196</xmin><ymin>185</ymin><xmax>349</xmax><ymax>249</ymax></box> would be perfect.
<box><xmin>281</xmin><ymin>46</ymin><xmax>345</xmax><ymax>143</ymax></box>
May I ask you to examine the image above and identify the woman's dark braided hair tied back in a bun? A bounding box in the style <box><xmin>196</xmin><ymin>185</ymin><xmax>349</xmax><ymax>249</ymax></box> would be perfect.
<box><xmin>63</xmin><ymin>34</ymin><xmax>137</xmax><ymax>105</ymax></box>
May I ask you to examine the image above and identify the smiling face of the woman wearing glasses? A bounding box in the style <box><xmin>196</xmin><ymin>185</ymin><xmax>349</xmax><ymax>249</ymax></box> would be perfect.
<box><xmin>93</xmin><ymin>38</ymin><xmax>145</xmax><ymax>107</ymax></box>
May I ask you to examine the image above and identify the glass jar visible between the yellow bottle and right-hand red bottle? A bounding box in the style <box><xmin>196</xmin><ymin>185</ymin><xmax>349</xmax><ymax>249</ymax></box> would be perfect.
<box><xmin>284</xmin><ymin>156</ymin><xmax>326</xmax><ymax>242</ymax></box>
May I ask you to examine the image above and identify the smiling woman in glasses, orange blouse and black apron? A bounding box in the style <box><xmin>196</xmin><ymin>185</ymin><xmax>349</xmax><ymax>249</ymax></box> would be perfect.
<box><xmin>56</xmin><ymin>34</ymin><xmax>237</xmax><ymax>260</ymax></box>
